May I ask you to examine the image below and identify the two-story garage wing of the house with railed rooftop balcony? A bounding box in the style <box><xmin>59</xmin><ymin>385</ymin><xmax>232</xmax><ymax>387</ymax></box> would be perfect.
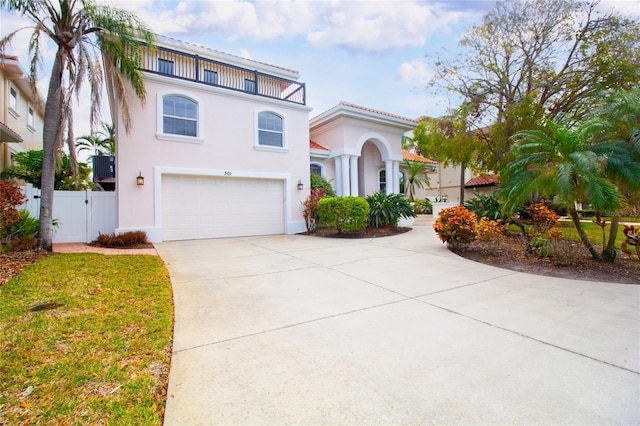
<box><xmin>108</xmin><ymin>37</ymin><xmax>311</xmax><ymax>242</ymax></box>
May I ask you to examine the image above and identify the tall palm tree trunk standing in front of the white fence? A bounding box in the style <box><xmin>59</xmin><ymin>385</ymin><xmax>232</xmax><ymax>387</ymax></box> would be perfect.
<box><xmin>39</xmin><ymin>48</ymin><xmax>64</xmax><ymax>251</ymax></box>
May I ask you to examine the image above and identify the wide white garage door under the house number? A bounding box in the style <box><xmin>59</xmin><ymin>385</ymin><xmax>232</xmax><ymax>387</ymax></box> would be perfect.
<box><xmin>162</xmin><ymin>175</ymin><xmax>284</xmax><ymax>241</ymax></box>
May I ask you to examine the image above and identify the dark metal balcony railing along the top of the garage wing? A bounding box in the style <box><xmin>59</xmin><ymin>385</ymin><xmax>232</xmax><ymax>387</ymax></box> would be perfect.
<box><xmin>143</xmin><ymin>46</ymin><xmax>306</xmax><ymax>105</ymax></box>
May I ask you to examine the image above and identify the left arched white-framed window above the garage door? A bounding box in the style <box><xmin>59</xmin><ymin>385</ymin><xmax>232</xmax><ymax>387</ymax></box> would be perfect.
<box><xmin>162</xmin><ymin>95</ymin><xmax>198</xmax><ymax>137</ymax></box>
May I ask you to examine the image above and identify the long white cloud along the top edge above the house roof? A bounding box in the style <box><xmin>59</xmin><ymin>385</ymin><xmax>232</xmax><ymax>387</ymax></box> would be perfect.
<box><xmin>109</xmin><ymin>0</ymin><xmax>470</xmax><ymax>52</ymax></box>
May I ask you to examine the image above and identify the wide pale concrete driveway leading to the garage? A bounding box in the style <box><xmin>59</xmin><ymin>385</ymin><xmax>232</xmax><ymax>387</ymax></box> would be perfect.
<box><xmin>156</xmin><ymin>226</ymin><xmax>640</xmax><ymax>425</ymax></box>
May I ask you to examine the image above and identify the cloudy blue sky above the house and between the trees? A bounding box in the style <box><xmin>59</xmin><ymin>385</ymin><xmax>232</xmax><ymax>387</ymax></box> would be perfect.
<box><xmin>0</xmin><ymin>0</ymin><xmax>640</xmax><ymax>140</ymax></box>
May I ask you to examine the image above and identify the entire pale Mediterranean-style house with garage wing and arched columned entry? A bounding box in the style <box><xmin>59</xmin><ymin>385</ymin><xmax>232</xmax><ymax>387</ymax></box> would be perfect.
<box><xmin>107</xmin><ymin>37</ymin><xmax>480</xmax><ymax>242</ymax></box>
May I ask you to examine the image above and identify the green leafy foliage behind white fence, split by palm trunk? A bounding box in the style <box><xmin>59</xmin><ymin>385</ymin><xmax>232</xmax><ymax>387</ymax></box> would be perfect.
<box><xmin>2</xmin><ymin>150</ymin><xmax>93</xmax><ymax>191</ymax></box>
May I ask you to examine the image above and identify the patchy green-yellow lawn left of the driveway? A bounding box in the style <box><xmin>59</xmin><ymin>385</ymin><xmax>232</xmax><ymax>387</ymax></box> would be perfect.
<box><xmin>0</xmin><ymin>254</ymin><xmax>173</xmax><ymax>425</ymax></box>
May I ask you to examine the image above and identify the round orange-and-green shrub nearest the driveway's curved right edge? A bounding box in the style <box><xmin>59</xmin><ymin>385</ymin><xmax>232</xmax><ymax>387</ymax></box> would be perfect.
<box><xmin>433</xmin><ymin>206</ymin><xmax>478</xmax><ymax>249</ymax></box>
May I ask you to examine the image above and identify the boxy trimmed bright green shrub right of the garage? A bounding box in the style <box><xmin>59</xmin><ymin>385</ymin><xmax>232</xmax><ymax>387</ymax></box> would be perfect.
<box><xmin>318</xmin><ymin>197</ymin><xmax>369</xmax><ymax>232</ymax></box>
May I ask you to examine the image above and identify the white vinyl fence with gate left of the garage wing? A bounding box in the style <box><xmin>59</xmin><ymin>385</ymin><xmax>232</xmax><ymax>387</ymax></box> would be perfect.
<box><xmin>20</xmin><ymin>184</ymin><xmax>118</xmax><ymax>243</ymax></box>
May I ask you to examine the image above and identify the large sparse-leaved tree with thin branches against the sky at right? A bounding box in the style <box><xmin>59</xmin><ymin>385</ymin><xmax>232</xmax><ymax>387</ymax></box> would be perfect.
<box><xmin>423</xmin><ymin>0</ymin><xmax>640</xmax><ymax>172</ymax></box>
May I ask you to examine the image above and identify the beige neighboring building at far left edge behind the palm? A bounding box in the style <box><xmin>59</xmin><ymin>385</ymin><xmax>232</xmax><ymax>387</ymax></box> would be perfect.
<box><xmin>0</xmin><ymin>55</ymin><xmax>44</xmax><ymax>171</ymax></box>
